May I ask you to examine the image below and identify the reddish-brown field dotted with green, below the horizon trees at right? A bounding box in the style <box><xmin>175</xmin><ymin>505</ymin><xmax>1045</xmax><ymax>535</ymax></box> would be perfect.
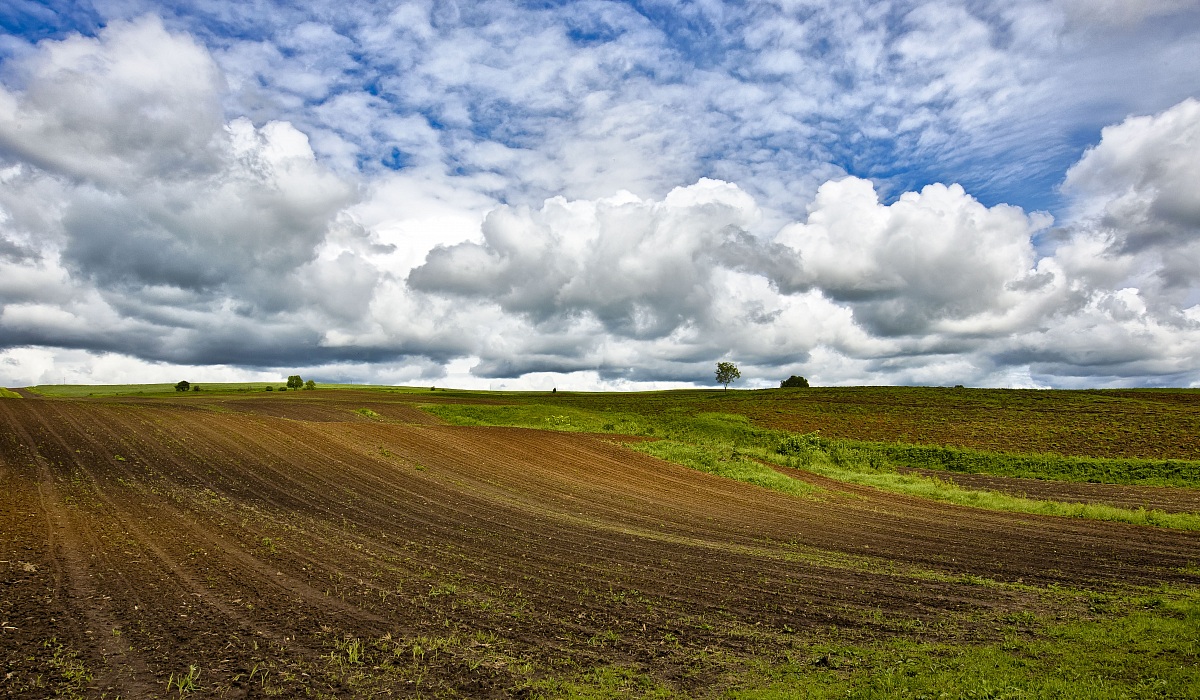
<box><xmin>540</xmin><ymin>387</ymin><xmax>1200</xmax><ymax>460</ymax></box>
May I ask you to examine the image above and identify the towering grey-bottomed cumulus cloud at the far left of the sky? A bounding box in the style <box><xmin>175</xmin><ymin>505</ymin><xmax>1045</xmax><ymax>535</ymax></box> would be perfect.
<box><xmin>0</xmin><ymin>18</ymin><xmax>379</xmax><ymax>364</ymax></box>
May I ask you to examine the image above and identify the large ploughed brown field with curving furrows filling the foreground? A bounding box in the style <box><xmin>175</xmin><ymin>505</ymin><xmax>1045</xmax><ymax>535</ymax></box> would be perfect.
<box><xmin>0</xmin><ymin>394</ymin><xmax>1200</xmax><ymax>698</ymax></box>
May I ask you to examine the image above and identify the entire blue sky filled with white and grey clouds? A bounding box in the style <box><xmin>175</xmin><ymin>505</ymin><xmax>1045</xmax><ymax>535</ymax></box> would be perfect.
<box><xmin>0</xmin><ymin>0</ymin><xmax>1200</xmax><ymax>390</ymax></box>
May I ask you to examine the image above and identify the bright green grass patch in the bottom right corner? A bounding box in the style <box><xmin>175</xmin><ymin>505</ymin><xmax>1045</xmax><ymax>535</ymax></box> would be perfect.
<box><xmin>726</xmin><ymin>592</ymin><xmax>1200</xmax><ymax>700</ymax></box>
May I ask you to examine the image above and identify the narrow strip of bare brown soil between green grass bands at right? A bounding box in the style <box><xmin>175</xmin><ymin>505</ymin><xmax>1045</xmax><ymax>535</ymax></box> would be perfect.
<box><xmin>899</xmin><ymin>467</ymin><xmax>1200</xmax><ymax>513</ymax></box>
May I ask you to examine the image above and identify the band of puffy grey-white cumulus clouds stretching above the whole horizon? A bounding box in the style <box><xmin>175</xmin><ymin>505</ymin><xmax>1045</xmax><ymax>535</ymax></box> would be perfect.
<box><xmin>0</xmin><ymin>17</ymin><xmax>1200</xmax><ymax>388</ymax></box>
